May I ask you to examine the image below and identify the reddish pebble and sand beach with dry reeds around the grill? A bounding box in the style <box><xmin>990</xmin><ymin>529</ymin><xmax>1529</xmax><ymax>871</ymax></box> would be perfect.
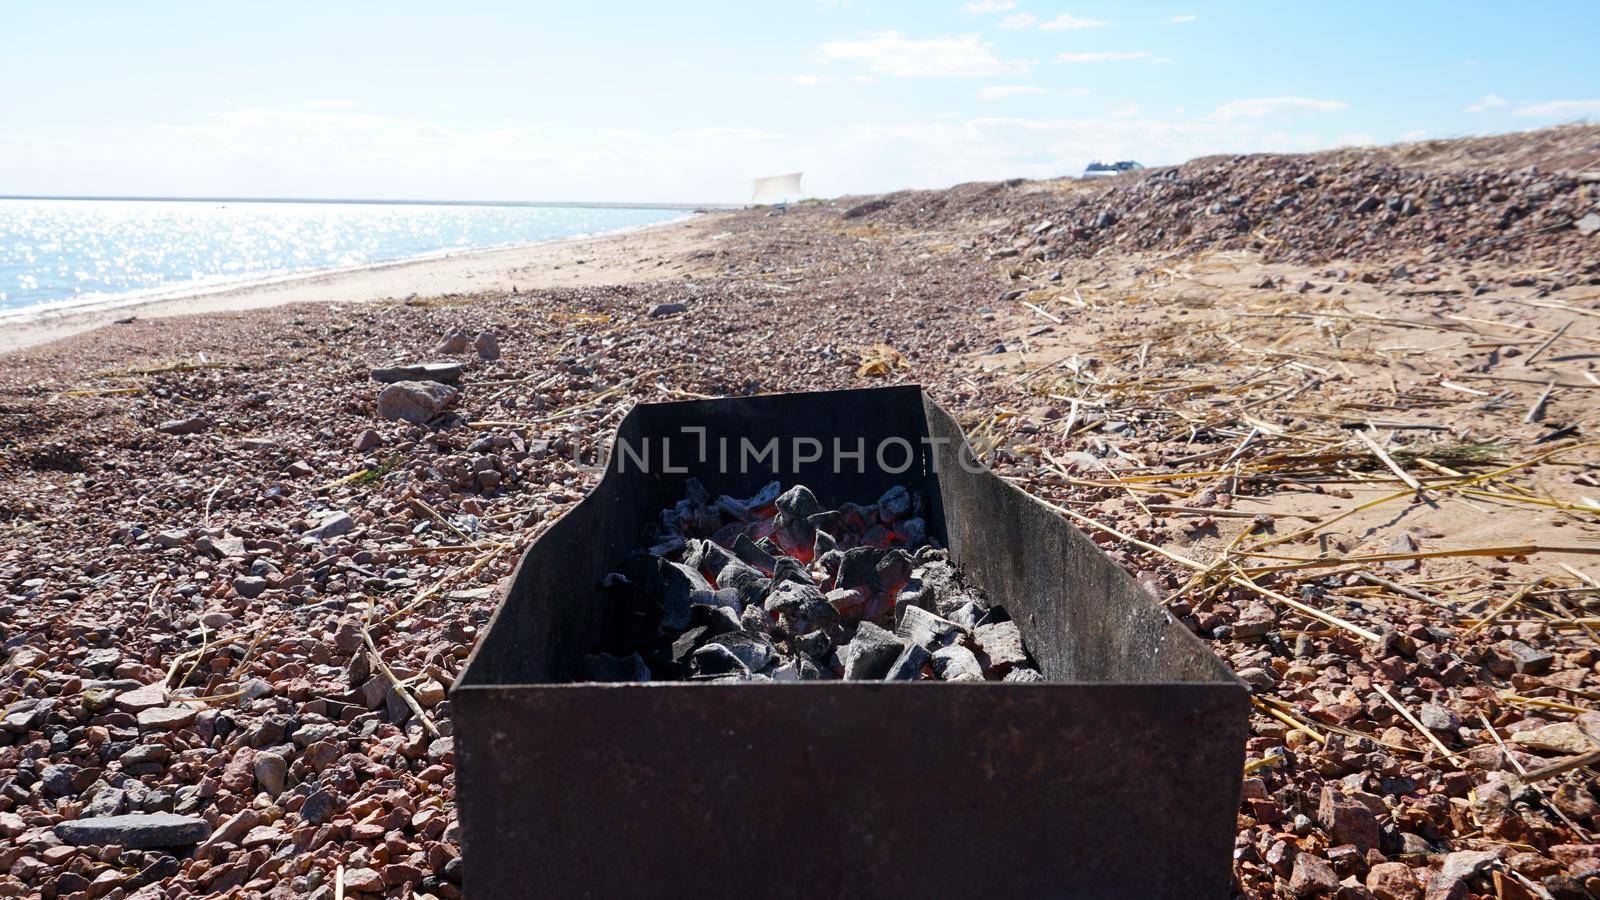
<box><xmin>0</xmin><ymin>127</ymin><xmax>1600</xmax><ymax>900</ymax></box>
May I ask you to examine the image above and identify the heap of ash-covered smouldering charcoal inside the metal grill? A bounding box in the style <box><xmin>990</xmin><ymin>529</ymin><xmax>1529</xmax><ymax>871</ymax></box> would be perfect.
<box><xmin>578</xmin><ymin>479</ymin><xmax>1043</xmax><ymax>682</ymax></box>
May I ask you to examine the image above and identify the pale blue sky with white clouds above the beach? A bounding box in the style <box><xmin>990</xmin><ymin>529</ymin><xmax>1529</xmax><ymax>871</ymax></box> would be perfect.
<box><xmin>0</xmin><ymin>0</ymin><xmax>1600</xmax><ymax>202</ymax></box>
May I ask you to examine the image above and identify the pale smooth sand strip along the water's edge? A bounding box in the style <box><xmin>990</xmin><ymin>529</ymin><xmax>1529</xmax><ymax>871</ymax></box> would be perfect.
<box><xmin>0</xmin><ymin>213</ymin><xmax>718</xmax><ymax>354</ymax></box>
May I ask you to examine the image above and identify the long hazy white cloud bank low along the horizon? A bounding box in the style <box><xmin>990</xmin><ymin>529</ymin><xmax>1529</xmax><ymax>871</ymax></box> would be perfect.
<box><xmin>0</xmin><ymin>101</ymin><xmax>1388</xmax><ymax>202</ymax></box>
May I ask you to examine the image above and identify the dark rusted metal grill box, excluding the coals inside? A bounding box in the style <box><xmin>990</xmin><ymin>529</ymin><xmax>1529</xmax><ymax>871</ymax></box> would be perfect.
<box><xmin>453</xmin><ymin>388</ymin><xmax>1248</xmax><ymax>898</ymax></box>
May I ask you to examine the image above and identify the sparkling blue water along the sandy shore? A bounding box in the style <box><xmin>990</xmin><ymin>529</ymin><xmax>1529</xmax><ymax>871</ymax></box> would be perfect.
<box><xmin>0</xmin><ymin>200</ymin><xmax>686</xmax><ymax>312</ymax></box>
